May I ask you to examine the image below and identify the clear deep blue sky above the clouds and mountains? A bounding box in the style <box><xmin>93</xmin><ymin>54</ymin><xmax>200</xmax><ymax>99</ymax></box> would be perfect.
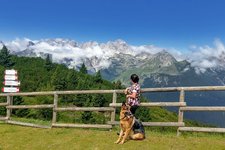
<box><xmin>0</xmin><ymin>0</ymin><xmax>225</xmax><ymax>50</ymax></box>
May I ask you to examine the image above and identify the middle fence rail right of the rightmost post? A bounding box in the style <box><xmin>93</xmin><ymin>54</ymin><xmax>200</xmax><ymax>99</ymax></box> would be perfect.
<box><xmin>180</xmin><ymin>106</ymin><xmax>225</xmax><ymax>111</ymax></box>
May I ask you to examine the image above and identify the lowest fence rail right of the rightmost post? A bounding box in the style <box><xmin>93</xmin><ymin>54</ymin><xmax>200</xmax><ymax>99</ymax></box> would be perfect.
<box><xmin>178</xmin><ymin>127</ymin><xmax>225</xmax><ymax>132</ymax></box>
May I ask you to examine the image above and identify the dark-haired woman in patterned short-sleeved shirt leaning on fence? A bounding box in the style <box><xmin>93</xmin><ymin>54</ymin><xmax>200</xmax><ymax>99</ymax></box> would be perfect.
<box><xmin>125</xmin><ymin>74</ymin><xmax>141</xmax><ymax>115</ymax></box>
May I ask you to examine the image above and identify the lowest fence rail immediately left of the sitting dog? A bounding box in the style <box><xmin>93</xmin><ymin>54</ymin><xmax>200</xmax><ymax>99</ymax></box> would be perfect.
<box><xmin>52</xmin><ymin>123</ymin><xmax>112</xmax><ymax>129</ymax></box>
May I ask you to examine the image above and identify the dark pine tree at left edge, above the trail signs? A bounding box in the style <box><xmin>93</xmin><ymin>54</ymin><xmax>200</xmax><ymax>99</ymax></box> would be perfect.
<box><xmin>0</xmin><ymin>45</ymin><xmax>14</xmax><ymax>68</ymax></box>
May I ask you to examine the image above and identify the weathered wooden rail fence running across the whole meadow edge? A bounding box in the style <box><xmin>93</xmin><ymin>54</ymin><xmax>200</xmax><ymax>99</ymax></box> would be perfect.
<box><xmin>0</xmin><ymin>86</ymin><xmax>225</xmax><ymax>135</ymax></box>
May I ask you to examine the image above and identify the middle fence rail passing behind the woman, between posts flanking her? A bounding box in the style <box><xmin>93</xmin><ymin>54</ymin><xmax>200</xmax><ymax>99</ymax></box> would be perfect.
<box><xmin>109</xmin><ymin>102</ymin><xmax>186</xmax><ymax>107</ymax></box>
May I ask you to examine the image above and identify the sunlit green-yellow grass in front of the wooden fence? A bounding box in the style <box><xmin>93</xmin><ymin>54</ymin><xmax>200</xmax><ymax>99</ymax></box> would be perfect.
<box><xmin>0</xmin><ymin>123</ymin><xmax>225</xmax><ymax>150</ymax></box>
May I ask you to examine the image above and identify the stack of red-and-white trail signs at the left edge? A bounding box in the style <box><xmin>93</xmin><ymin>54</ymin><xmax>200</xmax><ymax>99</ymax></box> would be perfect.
<box><xmin>2</xmin><ymin>69</ymin><xmax>20</xmax><ymax>93</ymax></box>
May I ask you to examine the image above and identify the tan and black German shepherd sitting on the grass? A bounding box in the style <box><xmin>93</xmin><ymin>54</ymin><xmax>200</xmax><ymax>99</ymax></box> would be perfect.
<box><xmin>115</xmin><ymin>102</ymin><xmax>145</xmax><ymax>144</ymax></box>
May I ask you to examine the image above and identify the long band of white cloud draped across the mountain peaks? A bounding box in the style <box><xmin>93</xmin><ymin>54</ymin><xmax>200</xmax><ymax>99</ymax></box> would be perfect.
<box><xmin>2</xmin><ymin>38</ymin><xmax>225</xmax><ymax>73</ymax></box>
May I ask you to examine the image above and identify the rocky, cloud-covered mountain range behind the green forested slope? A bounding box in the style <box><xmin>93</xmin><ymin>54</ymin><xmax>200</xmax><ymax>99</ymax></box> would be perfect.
<box><xmin>0</xmin><ymin>39</ymin><xmax>225</xmax><ymax>127</ymax></box>
